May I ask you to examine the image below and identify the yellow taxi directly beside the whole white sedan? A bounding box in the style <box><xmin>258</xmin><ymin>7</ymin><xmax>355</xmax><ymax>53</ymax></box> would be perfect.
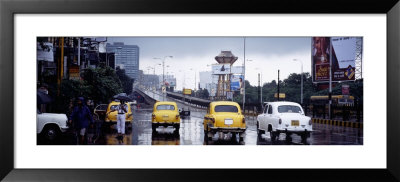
<box><xmin>203</xmin><ymin>101</ymin><xmax>246</xmax><ymax>141</ymax></box>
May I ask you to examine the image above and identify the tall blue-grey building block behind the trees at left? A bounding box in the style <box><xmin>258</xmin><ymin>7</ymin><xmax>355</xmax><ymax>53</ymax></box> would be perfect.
<box><xmin>107</xmin><ymin>42</ymin><xmax>139</xmax><ymax>82</ymax></box>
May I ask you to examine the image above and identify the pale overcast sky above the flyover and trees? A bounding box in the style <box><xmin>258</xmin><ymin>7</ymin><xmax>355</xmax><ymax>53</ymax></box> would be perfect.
<box><xmin>108</xmin><ymin>37</ymin><xmax>311</xmax><ymax>89</ymax></box>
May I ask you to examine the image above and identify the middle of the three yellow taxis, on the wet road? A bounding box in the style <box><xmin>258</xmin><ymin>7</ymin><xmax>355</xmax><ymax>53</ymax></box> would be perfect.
<box><xmin>151</xmin><ymin>101</ymin><xmax>181</xmax><ymax>133</ymax></box>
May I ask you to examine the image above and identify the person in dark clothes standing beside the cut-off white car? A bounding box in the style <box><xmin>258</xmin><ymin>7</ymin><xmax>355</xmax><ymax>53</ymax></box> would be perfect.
<box><xmin>69</xmin><ymin>97</ymin><xmax>94</xmax><ymax>144</ymax></box>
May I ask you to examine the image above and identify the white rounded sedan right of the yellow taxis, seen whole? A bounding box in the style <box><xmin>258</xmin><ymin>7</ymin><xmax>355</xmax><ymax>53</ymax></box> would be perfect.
<box><xmin>257</xmin><ymin>101</ymin><xmax>313</xmax><ymax>141</ymax></box>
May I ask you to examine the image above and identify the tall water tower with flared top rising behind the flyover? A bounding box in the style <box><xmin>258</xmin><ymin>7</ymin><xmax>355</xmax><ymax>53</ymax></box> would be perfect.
<box><xmin>213</xmin><ymin>51</ymin><xmax>238</xmax><ymax>100</ymax></box>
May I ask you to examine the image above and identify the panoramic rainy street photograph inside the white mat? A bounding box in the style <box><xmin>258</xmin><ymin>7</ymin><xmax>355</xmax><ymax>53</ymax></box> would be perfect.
<box><xmin>36</xmin><ymin>36</ymin><xmax>364</xmax><ymax>145</ymax></box>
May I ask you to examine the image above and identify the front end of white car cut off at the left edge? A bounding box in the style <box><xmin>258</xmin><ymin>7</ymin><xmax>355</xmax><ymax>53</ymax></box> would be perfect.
<box><xmin>36</xmin><ymin>111</ymin><xmax>68</xmax><ymax>141</ymax></box>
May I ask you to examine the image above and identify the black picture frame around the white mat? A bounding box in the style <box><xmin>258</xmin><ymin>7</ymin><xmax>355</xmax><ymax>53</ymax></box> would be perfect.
<box><xmin>0</xmin><ymin>0</ymin><xmax>400</xmax><ymax>181</ymax></box>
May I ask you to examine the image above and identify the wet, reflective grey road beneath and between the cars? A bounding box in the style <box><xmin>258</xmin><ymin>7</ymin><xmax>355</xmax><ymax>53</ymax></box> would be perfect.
<box><xmin>96</xmin><ymin>93</ymin><xmax>363</xmax><ymax>145</ymax></box>
